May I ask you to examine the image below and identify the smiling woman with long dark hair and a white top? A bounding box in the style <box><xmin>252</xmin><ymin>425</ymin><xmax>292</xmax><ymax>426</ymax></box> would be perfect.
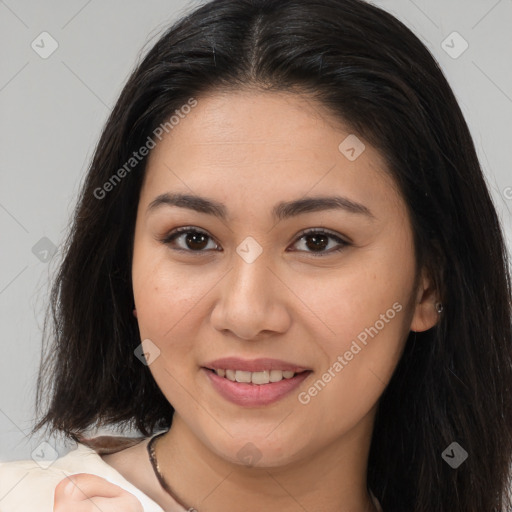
<box><xmin>0</xmin><ymin>0</ymin><xmax>512</xmax><ymax>512</ymax></box>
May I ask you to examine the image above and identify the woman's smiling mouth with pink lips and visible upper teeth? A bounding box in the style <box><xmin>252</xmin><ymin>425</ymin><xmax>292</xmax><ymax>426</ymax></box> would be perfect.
<box><xmin>201</xmin><ymin>358</ymin><xmax>312</xmax><ymax>407</ymax></box>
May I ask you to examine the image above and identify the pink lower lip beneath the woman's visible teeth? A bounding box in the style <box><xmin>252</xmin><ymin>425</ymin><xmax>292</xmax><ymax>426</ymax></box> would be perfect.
<box><xmin>202</xmin><ymin>368</ymin><xmax>311</xmax><ymax>407</ymax></box>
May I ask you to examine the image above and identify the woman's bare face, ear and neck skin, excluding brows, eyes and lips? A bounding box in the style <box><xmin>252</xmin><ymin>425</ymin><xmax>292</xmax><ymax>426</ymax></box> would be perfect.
<box><xmin>94</xmin><ymin>90</ymin><xmax>437</xmax><ymax>512</ymax></box>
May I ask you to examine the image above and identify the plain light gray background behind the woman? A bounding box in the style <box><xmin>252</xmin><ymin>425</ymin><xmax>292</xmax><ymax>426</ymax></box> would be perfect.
<box><xmin>0</xmin><ymin>0</ymin><xmax>512</xmax><ymax>461</ymax></box>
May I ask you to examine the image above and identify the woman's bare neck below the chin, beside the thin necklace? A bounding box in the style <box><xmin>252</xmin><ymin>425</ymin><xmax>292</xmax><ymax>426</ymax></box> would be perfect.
<box><xmin>156</xmin><ymin>411</ymin><xmax>377</xmax><ymax>512</ymax></box>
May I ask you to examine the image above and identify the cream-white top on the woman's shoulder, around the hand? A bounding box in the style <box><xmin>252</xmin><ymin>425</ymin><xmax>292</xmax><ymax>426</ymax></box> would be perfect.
<box><xmin>0</xmin><ymin>443</ymin><xmax>162</xmax><ymax>512</ymax></box>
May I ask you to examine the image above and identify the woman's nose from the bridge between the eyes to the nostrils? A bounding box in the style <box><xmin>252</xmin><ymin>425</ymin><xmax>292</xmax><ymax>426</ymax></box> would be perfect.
<box><xmin>211</xmin><ymin>251</ymin><xmax>291</xmax><ymax>340</ymax></box>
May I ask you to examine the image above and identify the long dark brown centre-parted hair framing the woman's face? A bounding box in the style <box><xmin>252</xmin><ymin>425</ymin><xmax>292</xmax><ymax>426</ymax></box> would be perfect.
<box><xmin>33</xmin><ymin>0</ymin><xmax>512</xmax><ymax>512</ymax></box>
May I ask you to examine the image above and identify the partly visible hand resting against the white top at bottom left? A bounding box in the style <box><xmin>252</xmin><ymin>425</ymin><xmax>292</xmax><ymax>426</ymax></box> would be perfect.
<box><xmin>53</xmin><ymin>473</ymin><xmax>144</xmax><ymax>512</ymax></box>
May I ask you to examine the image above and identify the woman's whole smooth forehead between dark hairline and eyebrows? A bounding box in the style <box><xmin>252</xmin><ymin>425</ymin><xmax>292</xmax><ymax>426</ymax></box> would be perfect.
<box><xmin>141</xmin><ymin>91</ymin><xmax>404</xmax><ymax>220</ymax></box>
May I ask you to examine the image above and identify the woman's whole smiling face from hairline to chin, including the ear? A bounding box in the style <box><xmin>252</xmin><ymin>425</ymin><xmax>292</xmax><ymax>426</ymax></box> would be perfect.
<box><xmin>132</xmin><ymin>91</ymin><xmax>435</xmax><ymax>466</ymax></box>
